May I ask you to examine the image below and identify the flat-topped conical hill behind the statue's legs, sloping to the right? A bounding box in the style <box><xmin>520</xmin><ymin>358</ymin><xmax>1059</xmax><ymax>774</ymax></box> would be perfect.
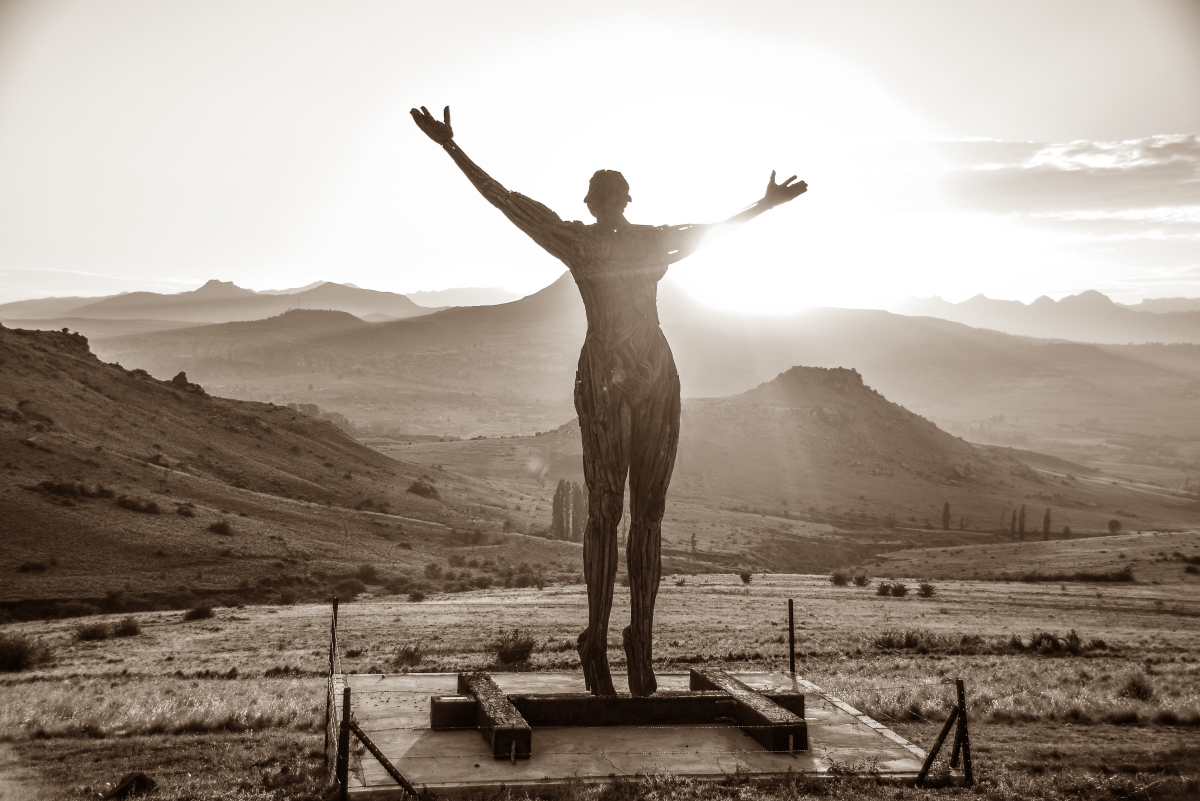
<box><xmin>374</xmin><ymin>367</ymin><xmax>1200</xmax><ymax>572</ymax></box>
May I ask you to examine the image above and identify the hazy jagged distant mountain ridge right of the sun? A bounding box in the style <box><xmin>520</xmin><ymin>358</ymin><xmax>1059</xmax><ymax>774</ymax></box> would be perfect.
<box><xmin>892</xmin><ymin>289</ymin><xmax>1200</xmax><ymax>344</ymax></box>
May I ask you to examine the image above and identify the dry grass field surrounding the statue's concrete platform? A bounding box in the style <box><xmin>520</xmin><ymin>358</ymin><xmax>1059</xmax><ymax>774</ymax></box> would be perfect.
<box><xmin>0</xmin><ymin>563</ymin><xmax>1200</xmax><ymax>800</ymax></box>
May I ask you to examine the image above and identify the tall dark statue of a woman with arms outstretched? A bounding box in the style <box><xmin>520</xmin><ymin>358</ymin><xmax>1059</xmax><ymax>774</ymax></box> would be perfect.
<box><xmin>412</xmin><ymin>107</ymin><xmax>808</xmax><ymax>695</ymax></box>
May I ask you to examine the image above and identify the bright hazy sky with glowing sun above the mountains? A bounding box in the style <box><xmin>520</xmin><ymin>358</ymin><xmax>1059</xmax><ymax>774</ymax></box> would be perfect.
<box><xmin>0</xmin><ymin>0</ymin><xmax>1200</xmax><ymax>309</ymax></box>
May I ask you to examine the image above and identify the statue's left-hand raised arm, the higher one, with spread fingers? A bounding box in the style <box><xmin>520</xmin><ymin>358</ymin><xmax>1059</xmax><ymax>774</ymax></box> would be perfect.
<box><xmin>409</xmin><ymin>106</ymin><xmax>571</xmax><ymax>261</ymax></box>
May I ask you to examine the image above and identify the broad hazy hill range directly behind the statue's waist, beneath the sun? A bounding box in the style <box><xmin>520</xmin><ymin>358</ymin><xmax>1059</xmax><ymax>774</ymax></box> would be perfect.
<box><xmin>84</xmin><ymin>275</ymin><xmax>1200</xmax><ymax>453</ymax></box>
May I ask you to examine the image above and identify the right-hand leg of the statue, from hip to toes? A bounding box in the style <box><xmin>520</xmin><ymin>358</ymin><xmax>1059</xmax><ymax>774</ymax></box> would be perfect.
<box><xmin>623</xmin><ymin>354</ymin><xmax>679</xmax><ymax>695</ymax></box>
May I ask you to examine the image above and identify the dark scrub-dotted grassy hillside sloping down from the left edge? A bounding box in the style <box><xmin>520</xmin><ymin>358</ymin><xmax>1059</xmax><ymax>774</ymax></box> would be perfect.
<box><xmin>0</xmin><ymin>327</ymin><xmax>577</xmax><ymax>602</ymax></box>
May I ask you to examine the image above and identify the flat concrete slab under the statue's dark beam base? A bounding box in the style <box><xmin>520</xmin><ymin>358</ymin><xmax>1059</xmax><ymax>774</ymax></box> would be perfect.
<box><xmin>338</xmin><ymin>673</ymin><xmax>925</xmax><ymax>799</ymax></box>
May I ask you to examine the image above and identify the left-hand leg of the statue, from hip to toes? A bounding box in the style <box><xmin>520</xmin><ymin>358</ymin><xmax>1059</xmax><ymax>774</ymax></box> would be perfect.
<box><xmin>575</xmin><ymin>345</ymin><xmax>630</xmax><ymax>695</ymax></box>
